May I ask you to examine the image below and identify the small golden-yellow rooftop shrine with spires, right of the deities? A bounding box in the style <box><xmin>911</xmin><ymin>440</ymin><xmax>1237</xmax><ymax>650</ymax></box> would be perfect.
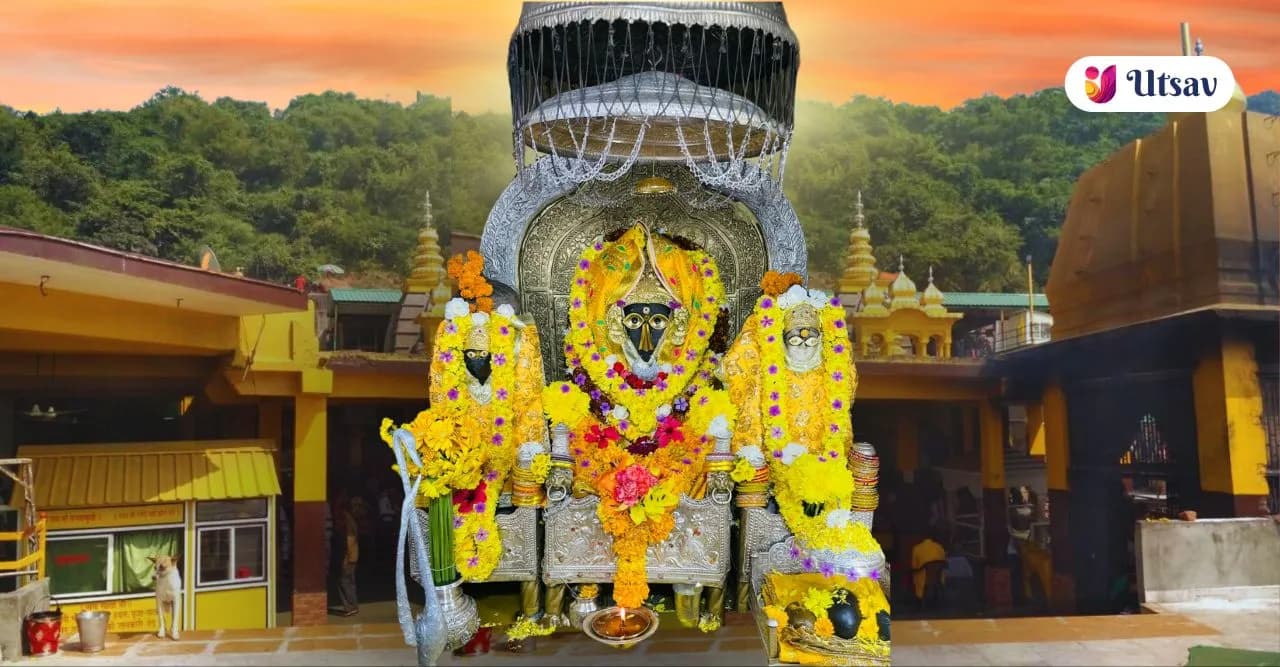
<box><xmin>840</xmin><ymin>192</ymin><xmax>964</xmax><ymax>360</ymax></box>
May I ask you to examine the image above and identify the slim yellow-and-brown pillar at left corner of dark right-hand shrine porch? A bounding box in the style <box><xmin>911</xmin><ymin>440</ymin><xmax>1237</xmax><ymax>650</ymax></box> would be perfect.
<box><xmin>1041</xmin><ymin>384</ymin><xmax>1075</xmax><ymax>613</ymax></box>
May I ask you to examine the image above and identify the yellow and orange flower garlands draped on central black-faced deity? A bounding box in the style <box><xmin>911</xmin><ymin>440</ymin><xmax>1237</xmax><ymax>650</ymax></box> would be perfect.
<box><xmin>543</xmin><ymin>233</ymin><xmax>736</xmax><ymax>607</ymax></box>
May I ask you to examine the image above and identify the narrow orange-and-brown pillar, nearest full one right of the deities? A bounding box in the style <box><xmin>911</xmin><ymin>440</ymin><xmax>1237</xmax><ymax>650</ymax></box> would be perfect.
<box><xmin>978</xmin><ymin>401</ymin><xmax>1012</xmax><ymax>608</ymax></box>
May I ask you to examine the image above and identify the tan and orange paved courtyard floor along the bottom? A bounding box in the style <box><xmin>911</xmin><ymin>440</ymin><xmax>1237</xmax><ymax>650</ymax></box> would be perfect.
<box><xmin>24</xmin><ymin>599</ymin><xmax>1280</xmax><ymax>667</ymax></box>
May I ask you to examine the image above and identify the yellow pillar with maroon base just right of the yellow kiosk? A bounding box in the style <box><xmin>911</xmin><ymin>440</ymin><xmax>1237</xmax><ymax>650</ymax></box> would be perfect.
<box><xmin>293</xmin><ymin>394</ymin><xmax>329</xmax><ymax>626</ymax></box>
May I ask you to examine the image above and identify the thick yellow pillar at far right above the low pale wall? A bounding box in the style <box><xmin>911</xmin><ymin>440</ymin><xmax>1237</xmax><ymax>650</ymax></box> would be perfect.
<box><xmin>1193</xmin><ymin>333</ymin><xmax>1267</xmax><ymax>517</ymax></box>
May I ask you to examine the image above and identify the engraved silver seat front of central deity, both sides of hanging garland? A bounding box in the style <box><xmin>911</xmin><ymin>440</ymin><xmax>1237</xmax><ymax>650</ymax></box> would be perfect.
<box><xmin>543</xmin><ymin>495</ymin><xmax>733</xmax><ymax>588</ymax></box>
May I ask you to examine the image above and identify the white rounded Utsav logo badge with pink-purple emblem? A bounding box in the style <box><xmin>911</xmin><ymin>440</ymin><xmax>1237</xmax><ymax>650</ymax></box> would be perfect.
<box><xmin>1064</xmin><ymin>55</ymin><xmax>1235</xmax><ymax>113</ymax></box>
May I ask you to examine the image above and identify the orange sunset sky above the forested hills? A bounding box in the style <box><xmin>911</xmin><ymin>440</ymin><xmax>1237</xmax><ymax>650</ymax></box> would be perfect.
<box><xmin>0</xmin><ymin>0</ymin><xmax>1280</xmax><ymax>111</ymax></box>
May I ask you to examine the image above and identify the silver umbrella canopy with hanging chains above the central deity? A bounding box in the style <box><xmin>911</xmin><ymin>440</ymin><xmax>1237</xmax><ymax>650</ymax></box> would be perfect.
<box><xmin>508</xmin><ymin>3</ymin><xmax>800</xmax><ymax>186</ymax></box>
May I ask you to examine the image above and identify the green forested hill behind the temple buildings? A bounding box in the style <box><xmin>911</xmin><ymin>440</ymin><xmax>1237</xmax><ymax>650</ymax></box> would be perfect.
<box><xmin>0</xmin><ymin>88</ymin><xmax>1264</xmax><ymax>289</ymax></box>
